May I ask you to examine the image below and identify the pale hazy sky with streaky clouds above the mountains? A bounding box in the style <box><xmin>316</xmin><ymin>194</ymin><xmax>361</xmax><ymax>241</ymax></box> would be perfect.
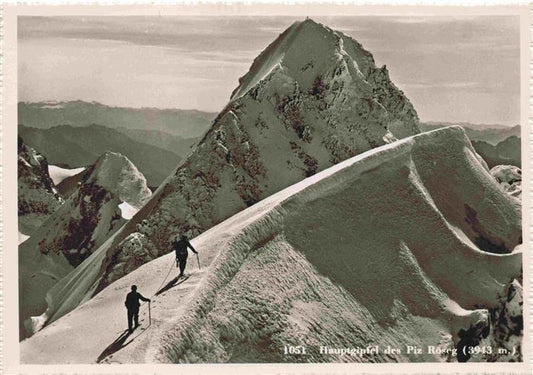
<box><xmin>18</xmin><ymin>16</ymin><xmax>520</xmax><ymax>125</ymax></box>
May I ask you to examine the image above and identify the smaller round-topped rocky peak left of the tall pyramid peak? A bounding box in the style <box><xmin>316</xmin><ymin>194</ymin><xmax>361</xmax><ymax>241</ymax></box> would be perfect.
<box><xmin>19</xmin><ymin>152</ymin><xmax>151</xmax><ymax>335</ymax></box>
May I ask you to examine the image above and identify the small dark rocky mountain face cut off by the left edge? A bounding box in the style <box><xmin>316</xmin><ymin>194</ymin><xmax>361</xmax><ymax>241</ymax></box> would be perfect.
<box><xmin>17</xmin><ymin>137</ymin><xmax>63</xmax><ymax>235</ymax></box>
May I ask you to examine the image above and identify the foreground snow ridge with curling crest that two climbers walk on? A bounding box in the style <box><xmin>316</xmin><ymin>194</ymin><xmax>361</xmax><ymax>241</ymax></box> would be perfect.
<box><xmin>21</xmin><ymin>127</ymin><xmax>522</xmax><ymax>363</ymax></box>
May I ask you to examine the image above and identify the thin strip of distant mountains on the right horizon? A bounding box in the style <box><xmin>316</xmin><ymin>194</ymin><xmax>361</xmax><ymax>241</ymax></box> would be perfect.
<box><xmin>420</xmin><ymin>122</ymin><xmax>521</xmax><ymax>146</ymax></box>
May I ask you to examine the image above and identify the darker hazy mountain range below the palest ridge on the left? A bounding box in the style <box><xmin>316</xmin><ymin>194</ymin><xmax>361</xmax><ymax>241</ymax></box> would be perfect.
<box><xmin>19</xmin><ymin>125</ymin><xmax>186</xmax><ymax>187</ymax></box>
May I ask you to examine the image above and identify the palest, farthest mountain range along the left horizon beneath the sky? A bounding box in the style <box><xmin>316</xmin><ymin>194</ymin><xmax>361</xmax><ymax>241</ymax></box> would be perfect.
<box><xmin>18</xmin><ymin>100</ymin><xmax>216</xmax><ymax>139</ymax></box>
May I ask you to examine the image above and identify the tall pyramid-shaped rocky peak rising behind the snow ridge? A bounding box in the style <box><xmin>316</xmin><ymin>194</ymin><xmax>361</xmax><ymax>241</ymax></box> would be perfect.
<box><xmin>41</xmin><ymin>20</ymin><xmax>419</xmax><ymax>316</ymax></box>
